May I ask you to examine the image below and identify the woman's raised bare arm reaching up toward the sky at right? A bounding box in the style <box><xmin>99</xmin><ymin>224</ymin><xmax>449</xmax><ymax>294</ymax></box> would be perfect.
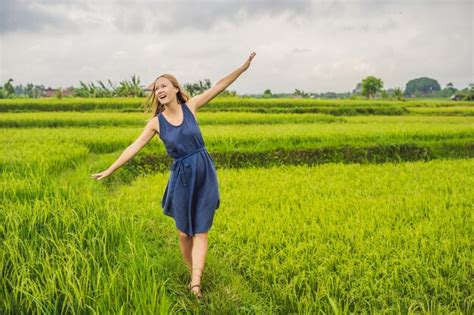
<box><xmin>187</xmin><ymin>52</ymin><xmax>256</xmax><ymax>112</ymax></box>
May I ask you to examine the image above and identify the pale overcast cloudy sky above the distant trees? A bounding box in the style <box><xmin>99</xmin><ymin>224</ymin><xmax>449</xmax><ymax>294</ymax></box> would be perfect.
<box><xmin>0</xmin><ymin>0</ymin><xmax>474</xmax><ymax>94</ymax></box>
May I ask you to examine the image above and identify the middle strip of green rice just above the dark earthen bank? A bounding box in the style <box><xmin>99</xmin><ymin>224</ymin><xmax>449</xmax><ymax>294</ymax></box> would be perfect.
<box><xmin>0</xmin><ymin>113</ymin><xmax>474</xmax><ymax>158</ymax></box>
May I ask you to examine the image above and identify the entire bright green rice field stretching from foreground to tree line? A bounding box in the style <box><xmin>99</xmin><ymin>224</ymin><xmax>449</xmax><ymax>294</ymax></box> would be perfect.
<box><xmin>0</xmin><ymin>98</ymin><xmax>474</xmax><ymax>314</ymax></box>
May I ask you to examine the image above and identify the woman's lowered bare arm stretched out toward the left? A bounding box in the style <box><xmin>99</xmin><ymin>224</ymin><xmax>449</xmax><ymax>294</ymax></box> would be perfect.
<box><xmin>91</xmin><ymin>116</ymin><xmax>160</xmax><ymax>180</ymax></box>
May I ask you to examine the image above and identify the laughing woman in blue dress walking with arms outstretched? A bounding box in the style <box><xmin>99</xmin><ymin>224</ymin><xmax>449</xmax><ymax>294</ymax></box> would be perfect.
<box><xmin>91</xmin><ymin>52</ymin><xmax>256</xmax><ymax>298</ymax></box>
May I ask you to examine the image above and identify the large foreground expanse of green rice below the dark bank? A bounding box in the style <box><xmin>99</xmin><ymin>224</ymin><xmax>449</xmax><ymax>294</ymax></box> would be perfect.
<box><xmin>0</xmin><ymin>157</ymin><xmax>474</xmax><ymax>313</ymax></box>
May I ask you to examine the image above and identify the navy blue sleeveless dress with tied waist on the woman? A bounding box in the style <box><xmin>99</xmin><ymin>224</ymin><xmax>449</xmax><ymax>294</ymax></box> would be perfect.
<box><xmin>156</xmin><ymin>103</ymin><xmax>220</xmax><ymax>236</ymax></box>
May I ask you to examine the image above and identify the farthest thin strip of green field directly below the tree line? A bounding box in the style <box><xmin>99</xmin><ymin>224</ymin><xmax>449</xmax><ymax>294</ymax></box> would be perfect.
<box><xmin>0</xmin><ymin>97</ymin><xmax>474</xmax><ymax>116</ymax></box>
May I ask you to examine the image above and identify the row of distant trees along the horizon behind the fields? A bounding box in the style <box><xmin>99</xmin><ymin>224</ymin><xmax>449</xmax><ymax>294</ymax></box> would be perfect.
<box><xmin>0</xmin><ymin>75</ymin><xmax>474</xmax><ymax>101</ymax></box>
